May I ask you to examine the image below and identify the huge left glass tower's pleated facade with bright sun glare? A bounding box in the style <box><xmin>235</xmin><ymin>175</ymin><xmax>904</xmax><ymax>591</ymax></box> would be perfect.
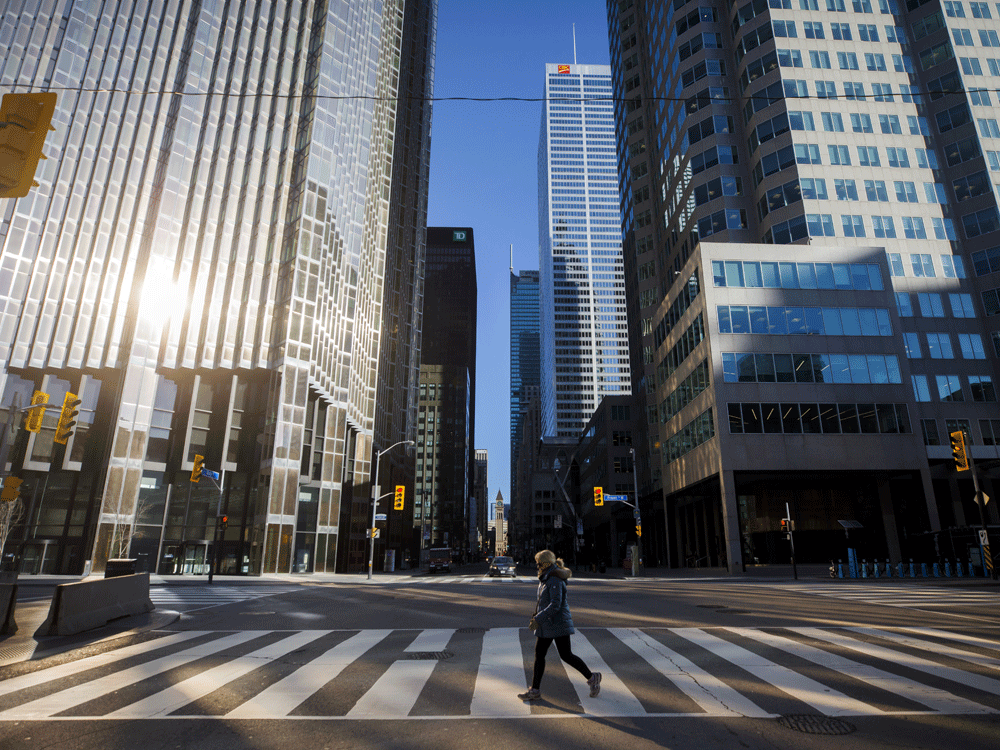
<box><xmin>0</xmin><ymin>0</ymin><xmax>433</xmax><ymax>574</ymax></box>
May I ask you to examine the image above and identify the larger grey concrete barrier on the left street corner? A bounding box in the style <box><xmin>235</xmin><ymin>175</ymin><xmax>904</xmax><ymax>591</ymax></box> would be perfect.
<box><xmin>35</xmin><ymin>573</ymin><xmax>155</xmax><ymax>637</ymax></box>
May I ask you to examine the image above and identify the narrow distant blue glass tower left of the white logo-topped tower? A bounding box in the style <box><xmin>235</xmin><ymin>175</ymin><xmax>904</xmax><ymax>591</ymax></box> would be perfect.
<box><xmin>510</xmin><ymin>268</ymin><xmax>541</xmax><ymax>515</ymax></box>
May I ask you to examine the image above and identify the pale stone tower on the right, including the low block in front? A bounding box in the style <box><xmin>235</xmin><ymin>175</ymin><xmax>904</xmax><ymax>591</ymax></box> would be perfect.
<box><xmin>608</xmin><ymin>0</ymin><xmax>1000</xmax><ymax>570</ymax></box>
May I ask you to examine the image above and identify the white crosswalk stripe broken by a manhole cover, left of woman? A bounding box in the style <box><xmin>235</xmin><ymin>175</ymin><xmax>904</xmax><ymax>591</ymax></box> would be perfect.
<box><xmin>347</xmin><ymin>630</ymin><xmax>455</xmax><ymax>719</ymax></box>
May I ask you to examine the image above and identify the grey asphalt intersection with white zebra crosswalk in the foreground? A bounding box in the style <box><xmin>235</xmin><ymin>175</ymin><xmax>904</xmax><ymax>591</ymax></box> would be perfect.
<box><xmin>0</xmin><ymin>576</ymin><xmax>1000</xmax><ymax>750</ymax></box>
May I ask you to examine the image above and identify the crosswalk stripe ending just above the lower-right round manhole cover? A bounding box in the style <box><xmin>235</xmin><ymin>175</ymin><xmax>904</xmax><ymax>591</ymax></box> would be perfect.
<box><xmin>670</xmin><ymin>628</ymin><xmax>883</xmax><ymax>716</ymax></box>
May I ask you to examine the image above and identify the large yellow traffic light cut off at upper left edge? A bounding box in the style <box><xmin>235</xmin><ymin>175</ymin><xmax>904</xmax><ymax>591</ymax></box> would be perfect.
<box><xmin>0</xmin><ymin>92</ymin><xmax>56</xmax><ymax>198</ymax></box>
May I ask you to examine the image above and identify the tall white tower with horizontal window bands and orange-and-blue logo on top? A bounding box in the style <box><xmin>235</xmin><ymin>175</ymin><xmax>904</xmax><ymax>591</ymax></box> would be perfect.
<box><xmin>538</xmin><ymin>64</ymin><xmax>631</xmax><ymax>438</ymax></box>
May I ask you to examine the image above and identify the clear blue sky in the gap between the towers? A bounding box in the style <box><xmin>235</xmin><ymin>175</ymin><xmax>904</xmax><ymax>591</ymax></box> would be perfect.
<box><xmin>427</xmin><ymin>0</ymin><xmax>608</xmax><ymax>516</ymax></box>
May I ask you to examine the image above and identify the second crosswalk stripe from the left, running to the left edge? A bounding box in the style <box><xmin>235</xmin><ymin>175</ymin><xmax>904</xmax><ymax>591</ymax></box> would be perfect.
<box><xmin>0</xmin><ymin>630</ymin><xmax>268</xmax><ymax>719</ymax></box>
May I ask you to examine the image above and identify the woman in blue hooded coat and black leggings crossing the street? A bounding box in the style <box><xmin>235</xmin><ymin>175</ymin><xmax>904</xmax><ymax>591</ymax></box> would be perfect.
<box><xmin>517</xmin><ymin>549</ymin><xmax>601</xmax><ymax>701</ymax></box>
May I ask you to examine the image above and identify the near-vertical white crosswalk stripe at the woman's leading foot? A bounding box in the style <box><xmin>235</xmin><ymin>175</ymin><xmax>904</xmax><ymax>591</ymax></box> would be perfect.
<box><xmin>470</xmin><ymin>628</ymin><xmax>531</xmax><ymax>717</ymax></box>
